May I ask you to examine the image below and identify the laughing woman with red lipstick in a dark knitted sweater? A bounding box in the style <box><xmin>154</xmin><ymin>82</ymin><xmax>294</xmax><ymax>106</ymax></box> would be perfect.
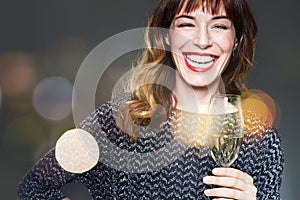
<box><xmin>18</xmin><ymin>0</ymin><xmax>283</xmax><ymax>199</ymax></box>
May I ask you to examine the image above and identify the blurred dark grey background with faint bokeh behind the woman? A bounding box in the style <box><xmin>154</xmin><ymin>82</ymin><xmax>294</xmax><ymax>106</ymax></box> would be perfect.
<box><xmin>0</xmin><ymin>0</ymin><xmax>300</xmax><ymax>200</ymax></box>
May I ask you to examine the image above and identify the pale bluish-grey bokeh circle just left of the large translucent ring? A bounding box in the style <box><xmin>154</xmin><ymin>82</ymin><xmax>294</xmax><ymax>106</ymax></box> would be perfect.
<box><xmin>33</xmin><ymin>76</ymin><xmax>73</xmax><ymax>120</ymax></box>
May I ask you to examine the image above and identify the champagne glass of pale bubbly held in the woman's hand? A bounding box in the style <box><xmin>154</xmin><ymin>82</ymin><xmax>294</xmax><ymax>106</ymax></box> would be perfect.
<box><xmin>207</xmin><ymin>94</ymin><xmax>244</xmax><ymax>167</ymax></box>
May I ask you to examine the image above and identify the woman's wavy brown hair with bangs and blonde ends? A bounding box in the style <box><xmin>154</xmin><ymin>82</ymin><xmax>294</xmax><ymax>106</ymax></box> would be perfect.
<box><xmin>118</xmin><ymin>0</ymin><xmax>257</xmax><ymax>133</ymax></box>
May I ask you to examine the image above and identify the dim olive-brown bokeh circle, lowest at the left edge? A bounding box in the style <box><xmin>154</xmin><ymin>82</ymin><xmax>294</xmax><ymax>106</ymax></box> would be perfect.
<box><xmin>1</xmin><ymin>117</ymin><xmax>46</xmax><ymax>161</ymax></box>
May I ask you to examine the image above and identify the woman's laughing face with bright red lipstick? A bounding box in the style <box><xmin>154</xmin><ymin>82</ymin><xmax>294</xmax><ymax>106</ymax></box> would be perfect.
<box><xmin>166</xmin><ymin>4</ymin><xmax>236</xmax><ymax>87</ymax></box>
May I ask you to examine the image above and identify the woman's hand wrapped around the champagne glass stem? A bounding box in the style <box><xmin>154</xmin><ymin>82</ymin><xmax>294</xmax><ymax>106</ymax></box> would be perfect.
<box><xmin>203</xmin><ymin>168</ymin><xmax>257</xmax><ymax>200</ymax></box>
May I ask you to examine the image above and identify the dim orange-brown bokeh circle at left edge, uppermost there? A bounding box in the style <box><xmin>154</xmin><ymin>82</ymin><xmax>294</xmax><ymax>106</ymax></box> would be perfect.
<box><xmin>0</xmin><ymin>52</ymin><xmax>36</xmax><ymax>97</ymax></box>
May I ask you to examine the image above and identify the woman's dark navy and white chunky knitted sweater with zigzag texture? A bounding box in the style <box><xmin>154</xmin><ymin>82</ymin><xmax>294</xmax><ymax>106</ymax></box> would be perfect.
<box><xmin>18</xmin><ymin>94</ymin><xmax>284</xmax><ymax>200</ymax></box>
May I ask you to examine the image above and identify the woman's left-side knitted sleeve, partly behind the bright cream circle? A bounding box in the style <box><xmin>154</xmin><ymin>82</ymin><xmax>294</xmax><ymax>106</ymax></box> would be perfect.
<box><xmin>18</xmin><ymin>98</ymin><xmax>118</xmax><ymax>200</ymax></box>
